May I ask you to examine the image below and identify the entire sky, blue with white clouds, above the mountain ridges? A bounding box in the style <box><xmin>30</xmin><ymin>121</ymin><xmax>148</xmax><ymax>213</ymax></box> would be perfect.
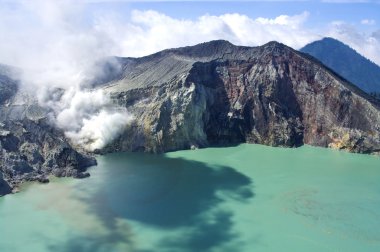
<box><xmin>0</xmin><ymin>0</ymin><xmax>380</xmax><ymax>64</ymax></box>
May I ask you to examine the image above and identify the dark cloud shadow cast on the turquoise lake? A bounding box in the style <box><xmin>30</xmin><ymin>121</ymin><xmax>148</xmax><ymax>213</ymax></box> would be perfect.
<box><xmin>51</xmin><ymin>153</ymin><xmax>254</xmax><ymax>252</ymax></box>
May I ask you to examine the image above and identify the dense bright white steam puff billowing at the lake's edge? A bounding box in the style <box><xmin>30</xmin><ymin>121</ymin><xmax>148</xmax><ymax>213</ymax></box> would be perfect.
<box><xmin>57</xmin><ymin>90</ymin><xmax>133</xmax><ymax>150</ymax></box>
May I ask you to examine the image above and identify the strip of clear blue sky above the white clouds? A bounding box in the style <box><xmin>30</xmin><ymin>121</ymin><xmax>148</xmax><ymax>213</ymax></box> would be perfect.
<box><xmin>86</xmin><ymin>1</ymin><xmax>380</xmax><ymax>29</ymax></box>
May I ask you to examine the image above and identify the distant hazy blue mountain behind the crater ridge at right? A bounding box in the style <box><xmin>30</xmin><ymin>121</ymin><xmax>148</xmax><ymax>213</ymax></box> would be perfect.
<box><xmin>300</xmin><ymin>38</ymin><xmax>380</xmax><ymax>93</ymax></box>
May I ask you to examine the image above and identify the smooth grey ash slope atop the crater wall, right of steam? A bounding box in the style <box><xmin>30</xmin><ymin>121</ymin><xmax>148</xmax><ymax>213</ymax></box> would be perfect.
<box><xmin>99</xmin><ymin>40</ymin><xmax>251</xmax><ymax>90</ymax></box>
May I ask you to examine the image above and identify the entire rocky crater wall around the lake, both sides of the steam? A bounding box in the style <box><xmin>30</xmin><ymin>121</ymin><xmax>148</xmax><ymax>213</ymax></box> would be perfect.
<box><xmin>0</xmin><ymin>41</ymin><xmax>380</xmax><ymax>195</ymax></box>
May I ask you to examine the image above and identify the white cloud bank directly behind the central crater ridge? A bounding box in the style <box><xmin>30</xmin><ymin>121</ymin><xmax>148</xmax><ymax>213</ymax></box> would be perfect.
<box><xmin>92</xmin><ymin>10</ymin><xmax>320</xmax><ymax>56</ymax></box>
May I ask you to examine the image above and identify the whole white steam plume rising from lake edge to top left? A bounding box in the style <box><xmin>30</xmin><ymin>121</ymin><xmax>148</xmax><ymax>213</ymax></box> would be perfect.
<box><xmin>0</xmin><ymin>0</ymin><xmax>132</xmax><ymax>151</ymax></box>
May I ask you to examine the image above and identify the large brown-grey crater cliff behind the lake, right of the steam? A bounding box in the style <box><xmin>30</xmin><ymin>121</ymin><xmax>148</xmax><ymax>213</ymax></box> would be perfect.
<box><xmin>98</xmin><ymin>41</ymin><xmax>380</xmax><ymax>153</ymax></box>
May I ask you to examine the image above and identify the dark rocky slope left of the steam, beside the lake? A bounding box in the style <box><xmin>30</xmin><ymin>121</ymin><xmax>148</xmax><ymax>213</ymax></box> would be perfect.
<box><xmin>0</xmin><ymin>66</ymin><xmax>96</xmax><ymax>196</ymax></box>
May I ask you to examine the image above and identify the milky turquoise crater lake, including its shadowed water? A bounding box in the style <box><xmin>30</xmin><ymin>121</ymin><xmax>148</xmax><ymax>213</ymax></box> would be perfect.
<box><xmin>0</xmin><ymin>144</ymin><xmax>380</xmax><ymax>252</ymax></box>
